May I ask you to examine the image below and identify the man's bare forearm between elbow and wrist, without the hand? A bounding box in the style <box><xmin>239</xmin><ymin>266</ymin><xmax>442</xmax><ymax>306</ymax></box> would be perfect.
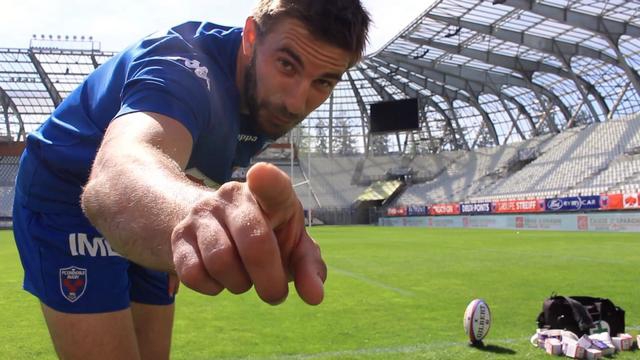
<box><xmin>82</xmin><ymin>144</ymin><xmax>210</xmax><ymax>271</ymax></box>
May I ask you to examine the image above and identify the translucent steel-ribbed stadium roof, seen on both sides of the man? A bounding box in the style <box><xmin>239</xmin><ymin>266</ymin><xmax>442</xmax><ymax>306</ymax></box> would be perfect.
<box><xmin>0</xmin><ymin>0</ymin><xmax>640</xmax><ymax>154</ymax></box>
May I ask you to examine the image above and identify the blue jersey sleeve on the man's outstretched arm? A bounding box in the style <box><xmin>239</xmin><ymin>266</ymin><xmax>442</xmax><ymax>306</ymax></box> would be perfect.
<box><xmin>116</xmin><ymin>56</ymin><xmax>210</xmax><ymax>141</ymax></box>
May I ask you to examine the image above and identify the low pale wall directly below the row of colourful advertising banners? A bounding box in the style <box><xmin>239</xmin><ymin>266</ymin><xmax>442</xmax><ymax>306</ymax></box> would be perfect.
<box><xmin>378</xmin><ymin>212</ymin><xmax>640</xmax><ymax>232</ymax></box>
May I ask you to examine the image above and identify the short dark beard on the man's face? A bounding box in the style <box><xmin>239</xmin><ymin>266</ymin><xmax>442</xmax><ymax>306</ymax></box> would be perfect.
<box><xmin>243</xmin><ymin>53</ymin><xmax>304</xmax><ymax>140</ymax></box>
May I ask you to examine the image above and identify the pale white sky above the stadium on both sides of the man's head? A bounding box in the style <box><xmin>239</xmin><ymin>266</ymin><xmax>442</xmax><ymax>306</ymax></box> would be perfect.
<box><xmin>0</xmin><ymin>0</ymin><xmax>433</xmax><ymax>53</ymax></box>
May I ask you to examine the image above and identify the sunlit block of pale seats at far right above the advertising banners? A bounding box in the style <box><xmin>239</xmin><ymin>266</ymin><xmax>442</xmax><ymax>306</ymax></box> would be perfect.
<box><xmin>470</xmin><ymin>119</ymin><xmax>640</xmax><ymax>201</ymax></box>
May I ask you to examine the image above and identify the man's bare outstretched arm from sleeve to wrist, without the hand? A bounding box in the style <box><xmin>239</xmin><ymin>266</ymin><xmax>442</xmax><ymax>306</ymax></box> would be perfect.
<box><xmin>82</xmin><ymin>112</ymin><xmax>199</xmax><ymax>271</ymax></box>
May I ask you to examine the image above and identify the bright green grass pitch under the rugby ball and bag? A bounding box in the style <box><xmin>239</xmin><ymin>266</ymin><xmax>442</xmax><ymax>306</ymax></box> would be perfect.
<box><xmin>0</xmin><ymin>226</ymin><xmax>640</xmax><ymax>359</ymax></box>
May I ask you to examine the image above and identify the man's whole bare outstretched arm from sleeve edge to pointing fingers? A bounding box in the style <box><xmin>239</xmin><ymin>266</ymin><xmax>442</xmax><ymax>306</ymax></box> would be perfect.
<box><xmin>82</xmin><ymin>113</ymin><xmax>326</xmax><ymax>304</ymax></box>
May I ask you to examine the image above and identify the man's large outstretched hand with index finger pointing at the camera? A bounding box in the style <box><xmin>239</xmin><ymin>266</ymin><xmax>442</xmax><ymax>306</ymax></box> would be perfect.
<box><xmin>171</xmin><ymin>163</ymin><xmax>327</xmax><ymax>305</ymax></box>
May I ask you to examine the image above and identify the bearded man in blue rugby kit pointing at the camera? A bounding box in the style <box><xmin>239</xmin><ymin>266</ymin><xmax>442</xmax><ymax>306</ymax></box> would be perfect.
<box><xmin>14</xmin><ymin>0</ymin><xmax>369</xmax><ymax>359</ymax></box>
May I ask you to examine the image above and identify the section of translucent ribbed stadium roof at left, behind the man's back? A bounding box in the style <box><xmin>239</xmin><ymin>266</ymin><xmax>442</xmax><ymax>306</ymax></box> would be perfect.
<box><xmin>0</xmin><ymin>36</ymin><xmax>114</xmax><ymax>140</ymax></box>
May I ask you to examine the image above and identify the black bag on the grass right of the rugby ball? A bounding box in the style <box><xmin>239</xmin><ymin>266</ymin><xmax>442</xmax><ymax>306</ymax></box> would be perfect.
<box><xmin>538</xmin><ymin>295</ymin><xmax>625</xmax><ymax>337</ymax></box>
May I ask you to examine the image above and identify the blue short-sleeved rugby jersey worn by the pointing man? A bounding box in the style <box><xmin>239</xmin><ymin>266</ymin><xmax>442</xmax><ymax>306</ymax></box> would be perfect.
<box><xmin>16</xmin><ymin>22</ymin><xmax>267</xmax><ymax>215</ymax></box>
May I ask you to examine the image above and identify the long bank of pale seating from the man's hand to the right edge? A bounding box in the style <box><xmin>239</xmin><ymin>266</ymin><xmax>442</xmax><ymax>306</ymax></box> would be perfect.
<box><xmin>262</xmin><ymin>116</ymin><xmax>640</xmax><ymax>208</ymax></box>
